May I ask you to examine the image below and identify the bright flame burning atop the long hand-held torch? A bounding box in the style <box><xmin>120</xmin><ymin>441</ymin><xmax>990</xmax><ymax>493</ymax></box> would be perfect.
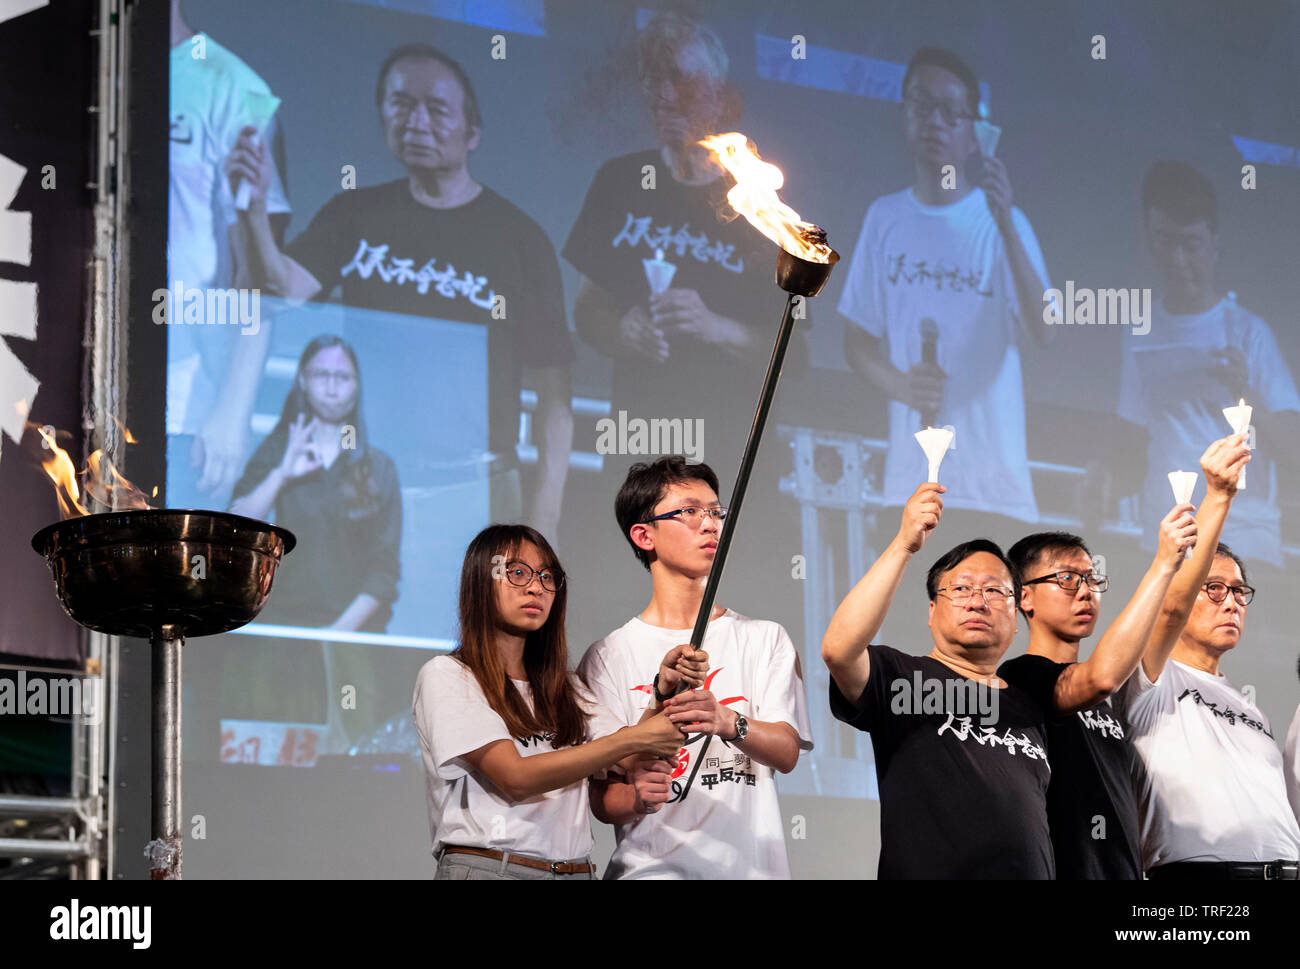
<box><xmin>699</xmin><ymin>131</ymin><xmax>832</xmax><ymax>263</ymax></box>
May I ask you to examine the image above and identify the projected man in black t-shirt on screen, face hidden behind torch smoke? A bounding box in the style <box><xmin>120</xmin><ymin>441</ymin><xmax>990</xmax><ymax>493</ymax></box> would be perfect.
<box><xmin>563</xmin><ymin>14</ymin><xmax>807</xmax><ymax>483</ymax></box>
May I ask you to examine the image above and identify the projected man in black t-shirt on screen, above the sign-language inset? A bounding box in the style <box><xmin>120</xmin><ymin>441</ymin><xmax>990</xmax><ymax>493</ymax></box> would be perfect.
<box><xmin>226</xmin><ymin>44</ymin><xmax>573</xmax><ymax>538</ymax></box>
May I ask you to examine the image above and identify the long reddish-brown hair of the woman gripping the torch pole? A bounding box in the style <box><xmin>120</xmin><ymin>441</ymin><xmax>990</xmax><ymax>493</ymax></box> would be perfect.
<box><xmin>452</xmin><ymin>524</ymin><xmax>586</xmax><ymax>748</ymax></box>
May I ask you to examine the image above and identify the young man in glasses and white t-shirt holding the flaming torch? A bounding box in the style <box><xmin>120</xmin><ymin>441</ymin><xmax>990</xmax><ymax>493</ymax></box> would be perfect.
<box><xmin>579</xmin><ymin>457</ymin><xmax>813</xmax><ymax>878</ymax></box>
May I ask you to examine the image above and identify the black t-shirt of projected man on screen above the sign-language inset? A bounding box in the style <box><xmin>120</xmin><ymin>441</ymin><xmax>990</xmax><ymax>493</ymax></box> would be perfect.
<box><xmin>286</xmin><ymin>178</ymin><xmax>573</xmax><ymax>455</ymax></box>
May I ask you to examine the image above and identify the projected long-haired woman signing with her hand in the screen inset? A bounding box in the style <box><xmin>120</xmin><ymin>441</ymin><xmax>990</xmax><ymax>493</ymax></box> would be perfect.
<box><xmin>228</xmin><ymin>334</ymin><xmax>402</xmax><ymax>740</ymax></box>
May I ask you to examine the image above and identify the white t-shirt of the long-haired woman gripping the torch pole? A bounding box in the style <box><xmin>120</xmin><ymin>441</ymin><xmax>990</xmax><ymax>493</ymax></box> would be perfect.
<box><xmin>413</xmin><ymin>656</ymin><xmax>624</xmax><ymax>861</ymax></box>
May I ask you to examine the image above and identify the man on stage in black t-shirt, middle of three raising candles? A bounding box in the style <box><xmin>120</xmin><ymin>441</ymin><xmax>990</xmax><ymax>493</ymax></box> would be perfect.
<box><xmin>997</xmin><ymin>515</ymin><xmax>1196</xmax><ymax>879</ymax></box>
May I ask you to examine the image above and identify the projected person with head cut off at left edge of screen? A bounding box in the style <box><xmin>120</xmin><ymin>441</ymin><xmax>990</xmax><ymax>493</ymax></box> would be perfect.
<box><xmin>166</xmin><ymin>0</ymin><xmax>289</xmax><ymax>509</ymax></box>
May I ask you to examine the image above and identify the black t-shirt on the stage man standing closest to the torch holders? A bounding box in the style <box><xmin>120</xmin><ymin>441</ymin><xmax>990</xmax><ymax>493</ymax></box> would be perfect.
<box><xmin>831</xmin><ymin>645</ymin><xmax>1054</xmax><ymax>879</ymax></box>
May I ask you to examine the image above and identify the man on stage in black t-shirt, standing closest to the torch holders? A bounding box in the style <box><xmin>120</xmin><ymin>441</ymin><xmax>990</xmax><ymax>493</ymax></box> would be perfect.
<box><xmin>822</xmin><ymin>483</ymin><xmax>1054</xmax><ymax>878</ymax></box>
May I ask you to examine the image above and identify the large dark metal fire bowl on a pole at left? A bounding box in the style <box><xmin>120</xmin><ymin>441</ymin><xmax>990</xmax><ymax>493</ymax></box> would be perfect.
<box><xmin>31</xmin><ymin>509</ymin><xmax>296</xmax><ymax>637</ymax></box>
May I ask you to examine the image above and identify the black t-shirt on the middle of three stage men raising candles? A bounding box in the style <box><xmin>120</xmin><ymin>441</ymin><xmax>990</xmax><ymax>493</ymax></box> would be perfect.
<box><xmin>997</xmin><ymin>654</ymin><xmax>1141</xmax><ymax>881</ymax></box>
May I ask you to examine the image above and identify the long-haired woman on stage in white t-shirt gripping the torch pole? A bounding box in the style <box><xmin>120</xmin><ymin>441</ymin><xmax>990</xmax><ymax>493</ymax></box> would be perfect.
<box><xmin>413</xmin><ymin>524</ymin><xmax>707</xmax><ymax>879</ymax></box>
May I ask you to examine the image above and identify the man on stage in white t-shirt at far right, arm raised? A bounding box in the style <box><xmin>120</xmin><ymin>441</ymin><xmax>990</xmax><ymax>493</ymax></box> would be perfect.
<box><xmin>1119</xmin><ymin>434</ymin><xmax>1300</xmax><ymax>881</ymax></box>
